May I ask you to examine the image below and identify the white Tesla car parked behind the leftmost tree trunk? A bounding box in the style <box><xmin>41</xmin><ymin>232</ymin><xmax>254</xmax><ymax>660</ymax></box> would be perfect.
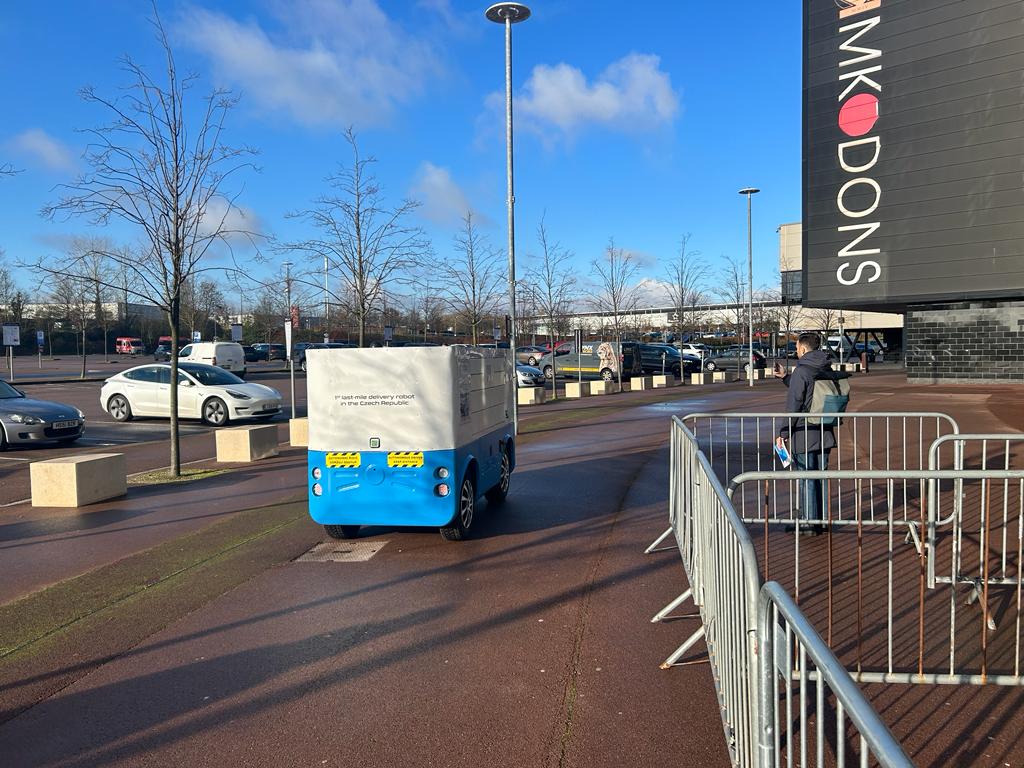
<box><xmin>99</xmin><ymin>362</ymin><xmax>281</xmax><ymax>427</ymax></box>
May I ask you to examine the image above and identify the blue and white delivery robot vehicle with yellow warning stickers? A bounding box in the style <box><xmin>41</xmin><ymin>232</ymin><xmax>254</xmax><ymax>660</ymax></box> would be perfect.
<box><xmin>306</xmin><ymin>346</ymin><xmax>515</xmax><ymax>541</ymax></box>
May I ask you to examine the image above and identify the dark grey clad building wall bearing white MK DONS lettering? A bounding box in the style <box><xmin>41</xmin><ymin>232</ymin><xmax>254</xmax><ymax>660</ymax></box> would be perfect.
<box><xmin>803</xmin><ymin>0</ymin><xmax>1024</xmax><ymax>308</ymax></box>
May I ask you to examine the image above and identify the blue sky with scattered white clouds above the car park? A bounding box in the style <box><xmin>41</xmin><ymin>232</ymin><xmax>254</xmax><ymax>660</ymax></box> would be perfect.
<box><xmin>0</xmin><ymin>0</ymin><xmax>801</xmax><ymax>307</ymax></box>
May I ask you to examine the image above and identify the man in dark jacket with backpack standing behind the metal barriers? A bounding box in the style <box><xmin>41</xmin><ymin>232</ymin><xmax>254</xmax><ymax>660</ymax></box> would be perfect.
<box><xmin>775</xmin><ymin>333</ymin><xmax>849</xmax><ymax>534</ymax></box>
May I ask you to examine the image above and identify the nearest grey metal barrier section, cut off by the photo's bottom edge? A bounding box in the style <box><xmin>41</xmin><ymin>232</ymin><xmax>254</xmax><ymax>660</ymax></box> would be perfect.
<box><xmin>758</xmin><ymin>582</ymin><xmax>913</xmax><ymax>768</ymax></box>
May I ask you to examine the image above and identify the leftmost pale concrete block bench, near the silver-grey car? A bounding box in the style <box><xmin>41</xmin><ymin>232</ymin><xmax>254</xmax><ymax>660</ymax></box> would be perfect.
<box><xmin>29</xmin><ymin>454</ymin><xmax>128</xmax><ymax>507</ymax></box>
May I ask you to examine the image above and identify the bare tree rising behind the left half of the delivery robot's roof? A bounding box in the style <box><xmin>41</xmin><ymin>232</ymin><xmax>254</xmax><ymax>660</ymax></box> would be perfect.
<box><xmin>285</xmin><ymin>128</ymin><xmax>430</xmax><ymax>347</ymax></box>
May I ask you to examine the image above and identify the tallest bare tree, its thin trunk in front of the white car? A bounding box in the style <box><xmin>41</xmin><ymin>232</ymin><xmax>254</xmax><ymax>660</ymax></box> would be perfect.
<box><xmin>35</xmin><ymin>13</ymin><xmax>255</xmax><ymax>475</ymax></box>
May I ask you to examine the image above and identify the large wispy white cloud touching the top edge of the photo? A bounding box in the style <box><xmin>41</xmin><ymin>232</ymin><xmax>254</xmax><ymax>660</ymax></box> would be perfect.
<box><xmin>179</xmin><ymin>0</ymin><xmax>439</xmax><ymax>127</ymax></box>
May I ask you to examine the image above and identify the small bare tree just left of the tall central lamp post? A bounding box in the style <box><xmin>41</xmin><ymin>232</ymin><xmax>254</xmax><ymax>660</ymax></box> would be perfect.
<box><xmin>438</xmin><ymin>211</ymin><xmax>505</xmax><ymax>344</ymax></box>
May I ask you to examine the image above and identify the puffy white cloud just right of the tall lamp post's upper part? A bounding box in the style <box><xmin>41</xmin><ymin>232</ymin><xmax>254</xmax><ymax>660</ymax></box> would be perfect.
<box><xmin>501</xmin><ymin>53</ymin><xmax>679</xmax><ymax>138</ymax></box>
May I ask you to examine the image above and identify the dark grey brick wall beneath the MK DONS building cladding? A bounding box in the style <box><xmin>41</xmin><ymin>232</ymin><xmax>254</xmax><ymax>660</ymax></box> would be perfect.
<box><xmin>903</xmin><ymin>301</ymin><xmax>1024</xmax><ymax>384</ymax></box>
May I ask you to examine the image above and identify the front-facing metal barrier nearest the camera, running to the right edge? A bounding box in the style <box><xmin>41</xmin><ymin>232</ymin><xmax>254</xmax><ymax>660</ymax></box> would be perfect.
<box><xmin>728</xmin><ymin>470</ymin><xmax>1024</xmax><ymax>686</ymax></box>
